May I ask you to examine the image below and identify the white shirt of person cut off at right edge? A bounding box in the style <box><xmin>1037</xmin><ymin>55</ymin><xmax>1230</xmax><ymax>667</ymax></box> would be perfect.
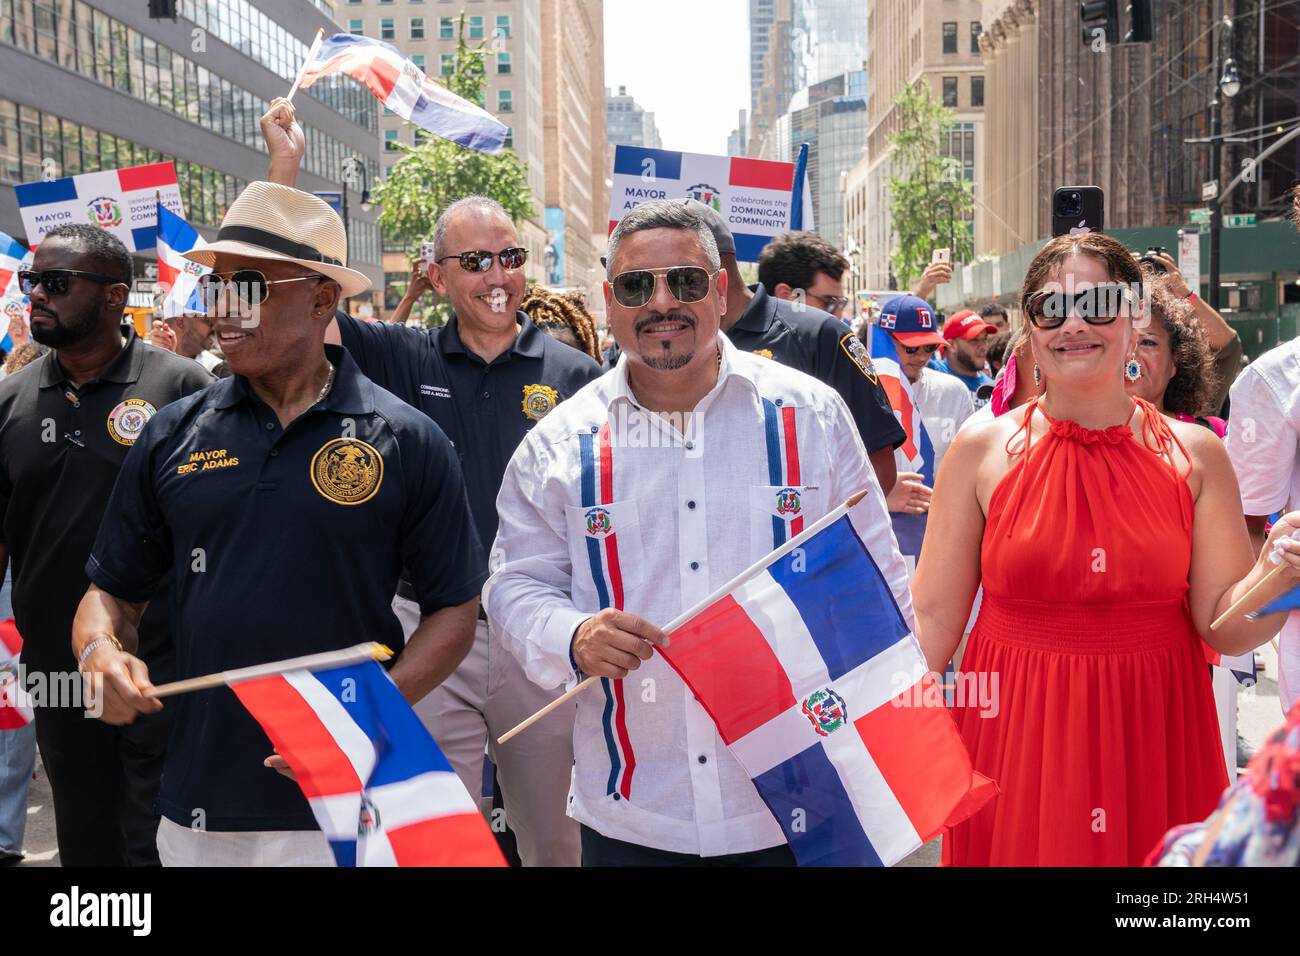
<box><xmin>1227</xmin><ymin>338</ymin><xmax>1300</xmax><ymax>713</ymax></box>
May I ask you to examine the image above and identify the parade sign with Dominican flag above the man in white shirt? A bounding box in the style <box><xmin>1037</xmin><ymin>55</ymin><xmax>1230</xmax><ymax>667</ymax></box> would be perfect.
<box><xmin>610</xmin><ymin>146</ymin><xmax>813</xmax><ymax>263</ymax></box>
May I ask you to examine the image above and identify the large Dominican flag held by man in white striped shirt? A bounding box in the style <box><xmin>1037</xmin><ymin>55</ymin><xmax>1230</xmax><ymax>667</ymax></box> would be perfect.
<box><xmin>663</xmin><ymin>494</ymin><xmax>997</xmax><ymax>866</ymax></box>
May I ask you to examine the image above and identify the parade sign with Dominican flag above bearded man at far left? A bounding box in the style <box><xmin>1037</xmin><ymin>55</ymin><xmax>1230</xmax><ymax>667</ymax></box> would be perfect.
<box><xmin>13</xmin><ymin>163</ymin><xmax>185</xmax><ymax>252</ymax></box>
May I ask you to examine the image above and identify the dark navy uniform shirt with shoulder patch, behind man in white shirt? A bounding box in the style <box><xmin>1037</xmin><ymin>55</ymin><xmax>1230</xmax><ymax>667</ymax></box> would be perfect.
<box><xmin>727</xmin><ymin>282</ymin><xmax>907</xmax><ymax>454</ymax></box>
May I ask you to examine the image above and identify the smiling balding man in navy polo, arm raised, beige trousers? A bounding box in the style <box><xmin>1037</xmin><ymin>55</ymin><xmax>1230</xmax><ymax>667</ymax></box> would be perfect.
<box><xmin>269</xmin><ymin>99</ymin><xmax>603</xmax><ymax>866</ymax></box>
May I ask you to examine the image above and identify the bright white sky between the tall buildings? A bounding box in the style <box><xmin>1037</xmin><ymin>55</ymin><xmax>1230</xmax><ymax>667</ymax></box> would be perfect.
<box><xmin>605</xmin><ymin>0</ymin><xmax>749</xmax><ymax>153</ymax></box>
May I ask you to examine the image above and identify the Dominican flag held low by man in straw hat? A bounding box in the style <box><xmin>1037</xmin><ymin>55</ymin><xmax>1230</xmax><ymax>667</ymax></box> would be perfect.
<box><xmin>230</xmin><ymin>661</ymin><xmax>506</xmax><ymax>866</ymax></box>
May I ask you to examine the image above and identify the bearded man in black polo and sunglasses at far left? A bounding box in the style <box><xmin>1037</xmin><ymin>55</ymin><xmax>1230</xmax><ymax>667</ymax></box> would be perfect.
<box><xmin>0</xmin><ymin>225</ymin><xmax>212</xmax><ymax>866</ymax></box>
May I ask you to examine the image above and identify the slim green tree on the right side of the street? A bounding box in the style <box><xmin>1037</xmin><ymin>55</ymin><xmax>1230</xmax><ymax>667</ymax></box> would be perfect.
<box><xmin>889</xmin><ymin>81</ymin><xmax>974</xmax><ymax>289</ymax></box>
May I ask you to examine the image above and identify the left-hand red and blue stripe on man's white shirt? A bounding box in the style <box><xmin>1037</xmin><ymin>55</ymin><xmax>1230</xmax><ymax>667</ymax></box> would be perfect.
<box><xmin>579</xmin><ymin>421</ymin><xmax>637</xmax><ymax>800</ymax></box>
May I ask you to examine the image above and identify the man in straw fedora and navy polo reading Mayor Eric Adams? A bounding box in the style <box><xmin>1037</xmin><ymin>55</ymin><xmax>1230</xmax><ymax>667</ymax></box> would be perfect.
<box><xmin>73</xmin><ymin>182</ymin><xmax>484</xmax><ymax>865</ymax></box>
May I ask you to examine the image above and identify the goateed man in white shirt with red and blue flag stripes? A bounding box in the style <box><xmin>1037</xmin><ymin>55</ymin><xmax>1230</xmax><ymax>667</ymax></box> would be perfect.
<box><xmin>484</xmin><ymin>200</ymin><xmax>911</xmax><ymax>866</ymax></box>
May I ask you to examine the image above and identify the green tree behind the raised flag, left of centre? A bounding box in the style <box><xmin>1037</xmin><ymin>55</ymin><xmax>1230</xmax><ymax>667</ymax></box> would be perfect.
<box><xmin>374</xmin><ymin>12</ymin><xmax>537</xmax><ymax>325</ymax></box>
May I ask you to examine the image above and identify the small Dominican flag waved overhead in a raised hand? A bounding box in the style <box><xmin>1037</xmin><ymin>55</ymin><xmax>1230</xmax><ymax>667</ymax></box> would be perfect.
<box><xmin>299</xmin><ymin>34</ymin><xmax>510</xmax><ymax>153</ymax></box>
